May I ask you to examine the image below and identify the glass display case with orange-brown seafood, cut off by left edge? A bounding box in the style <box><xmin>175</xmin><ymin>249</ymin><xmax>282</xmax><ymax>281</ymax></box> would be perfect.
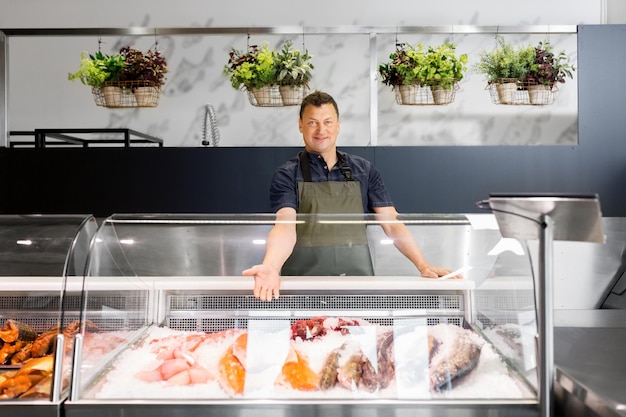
<box><xmin>0</xmin><ymin>215</ymin><xmax>97</xmax><ymax>417</ymax></box>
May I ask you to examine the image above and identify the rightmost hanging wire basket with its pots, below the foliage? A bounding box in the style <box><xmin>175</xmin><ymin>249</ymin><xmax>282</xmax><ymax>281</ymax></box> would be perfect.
<box><xmin>486</xmin><ymin>78</ymin><xmax>559</xmax><ymax>106</ymax></box>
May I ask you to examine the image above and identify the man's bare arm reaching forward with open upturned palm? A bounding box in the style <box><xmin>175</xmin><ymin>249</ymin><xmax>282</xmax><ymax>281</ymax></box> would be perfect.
<box><xmin>242</xmin><ymin>207</ymin><xmax>296</xmax><ymax>301</ymax></box>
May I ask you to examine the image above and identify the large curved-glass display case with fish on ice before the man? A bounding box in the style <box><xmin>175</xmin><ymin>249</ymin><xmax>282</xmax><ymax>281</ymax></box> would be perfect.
<box><xmin>64</xmin><ymin>214</ymin><xmax>539</xmax><ymax>417</ymax></box>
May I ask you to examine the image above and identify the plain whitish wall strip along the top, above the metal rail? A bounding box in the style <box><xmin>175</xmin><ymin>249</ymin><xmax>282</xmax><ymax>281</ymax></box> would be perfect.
<box><xmin>0</xmin><ymin>0</ymin><xmax>608</xmax><ymax>28</ymax></box>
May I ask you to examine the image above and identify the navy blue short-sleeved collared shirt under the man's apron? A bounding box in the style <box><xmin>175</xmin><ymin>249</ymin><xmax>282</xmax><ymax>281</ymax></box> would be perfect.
<box><xmin>270</xmin><ymin>151</ymin><xmax>393</xmax><ymax>213</ymax></box>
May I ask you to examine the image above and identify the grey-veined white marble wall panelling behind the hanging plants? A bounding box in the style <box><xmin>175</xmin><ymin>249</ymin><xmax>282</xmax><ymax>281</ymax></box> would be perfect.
<box><xmin>9</xmin><ymin>29</ymin><xmax>577</xmax><ymax>146</ymax></box>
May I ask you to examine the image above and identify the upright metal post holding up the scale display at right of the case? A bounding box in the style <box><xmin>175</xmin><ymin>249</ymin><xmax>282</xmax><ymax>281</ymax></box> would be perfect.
<box><xmin>537</xmin><ymin>215</ymin><xmax>554</xmax><ymax>417</ymax></box>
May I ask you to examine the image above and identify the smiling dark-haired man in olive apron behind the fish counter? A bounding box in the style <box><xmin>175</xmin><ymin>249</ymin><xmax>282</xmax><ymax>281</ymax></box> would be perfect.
<box><xmin>243</xmin><ymin>91</ymin><xmax>450</xmax><ymax>301</ymax></box>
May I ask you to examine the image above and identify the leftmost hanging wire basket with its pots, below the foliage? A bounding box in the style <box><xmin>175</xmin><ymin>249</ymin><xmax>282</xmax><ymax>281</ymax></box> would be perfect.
<box><xmin>91</xmin><ymin>81</ymin><xmax>161</xmax><ymax>108</ymax></box>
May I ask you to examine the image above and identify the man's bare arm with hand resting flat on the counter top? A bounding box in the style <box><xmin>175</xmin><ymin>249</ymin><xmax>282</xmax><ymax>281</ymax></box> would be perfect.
<box><xmin>374</xmin><ymin>207</ymin><xmax>460</xmax><ymax>278</ymax></box>
